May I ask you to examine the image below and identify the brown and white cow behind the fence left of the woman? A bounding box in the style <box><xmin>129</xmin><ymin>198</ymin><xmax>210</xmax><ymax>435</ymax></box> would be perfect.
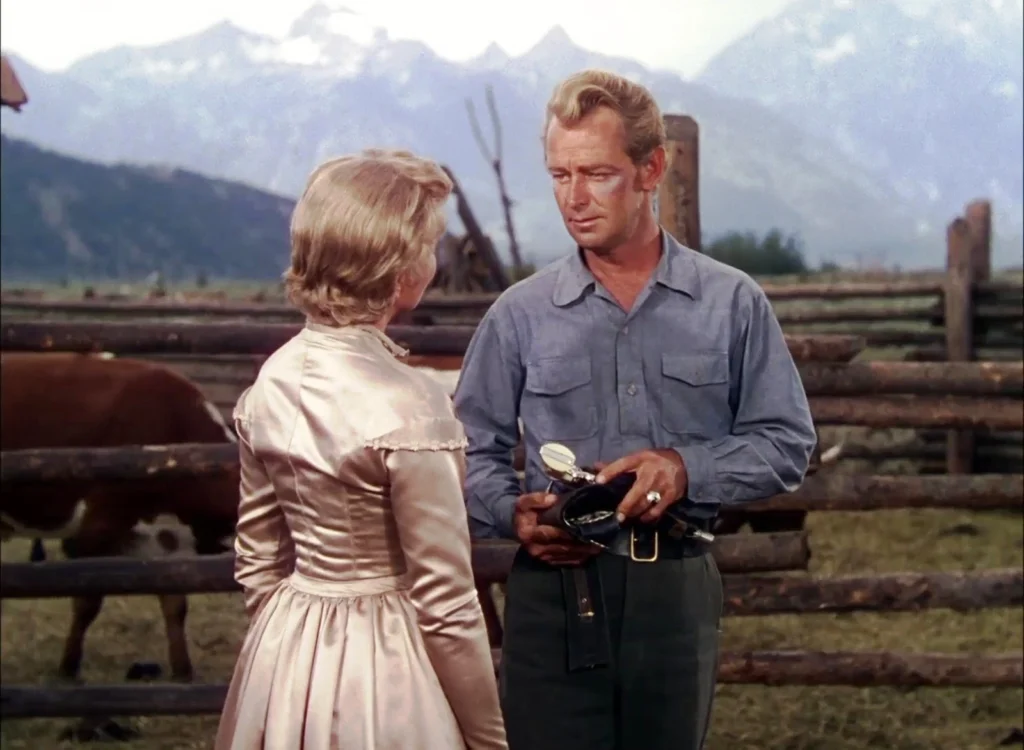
<box><xmin>0</xmin><ymin>352</ymin><xmax>239</xmax><ymax>680</ymax></box>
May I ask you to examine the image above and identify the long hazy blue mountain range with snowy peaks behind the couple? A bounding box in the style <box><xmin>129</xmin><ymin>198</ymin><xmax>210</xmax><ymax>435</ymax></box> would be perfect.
<box><xmin>2</xmin><ymin>3</ymin><xmax>1019</xmax><ymax>266</ymax></box>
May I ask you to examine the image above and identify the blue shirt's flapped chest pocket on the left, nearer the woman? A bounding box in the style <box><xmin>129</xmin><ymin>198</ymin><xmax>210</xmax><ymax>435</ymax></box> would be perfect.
<box><xmin>522</xmin><ymin>356</ymin><xmax>598</xmax><ymax>441</ymax></box>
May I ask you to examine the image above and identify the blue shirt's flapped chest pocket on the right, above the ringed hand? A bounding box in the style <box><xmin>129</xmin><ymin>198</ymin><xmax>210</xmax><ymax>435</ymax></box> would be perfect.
<box><xmin>660</xmin><ymin>351</ymin><xmax>733</xmax><ymax>439</ymax></box>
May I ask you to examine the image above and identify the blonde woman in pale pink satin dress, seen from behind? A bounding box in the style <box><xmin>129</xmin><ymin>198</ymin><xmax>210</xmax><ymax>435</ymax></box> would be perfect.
<box><xmin>215</xmin><ymin>151</ymin><xmax>507</xmax><ymax>750</ymax></box>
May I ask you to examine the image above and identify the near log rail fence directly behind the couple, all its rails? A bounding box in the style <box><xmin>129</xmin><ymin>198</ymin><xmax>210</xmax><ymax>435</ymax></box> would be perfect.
<box><xmin>0</xmin><ymin>322</ymin><xmax>1024</xmax><ymax>718</ymax></box>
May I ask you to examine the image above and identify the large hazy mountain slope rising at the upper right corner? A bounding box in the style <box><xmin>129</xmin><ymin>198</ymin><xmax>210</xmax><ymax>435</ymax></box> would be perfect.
<box><xmin>697</xmin><ymin>0</ymin><xmax>1024</xmax><ymax>252</ymax></box>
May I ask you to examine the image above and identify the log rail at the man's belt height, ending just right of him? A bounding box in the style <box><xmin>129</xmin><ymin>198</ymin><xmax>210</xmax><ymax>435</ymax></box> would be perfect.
<box><xmin>0</xmin><ymin>532</ymin><xmax>811</xmax><ymax>599</ymax></box>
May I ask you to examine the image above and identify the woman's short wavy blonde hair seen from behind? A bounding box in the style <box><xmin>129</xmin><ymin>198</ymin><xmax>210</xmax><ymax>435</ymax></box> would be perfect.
<box><xmin>284</xmin><ymin>149</ymin><xmax>452</xmax><ymax>325</ymax></box>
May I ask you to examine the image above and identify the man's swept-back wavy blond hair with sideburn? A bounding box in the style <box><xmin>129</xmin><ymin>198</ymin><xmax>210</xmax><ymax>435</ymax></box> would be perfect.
<box><xmin>544</xmin><ymin>70</ymin><xmax>665</xmax><ymax>165</ymax></box>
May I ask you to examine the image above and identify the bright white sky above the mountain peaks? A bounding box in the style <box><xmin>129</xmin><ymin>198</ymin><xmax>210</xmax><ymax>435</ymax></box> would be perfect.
<box><xmin>0</xmin><ymin>0</ymin><xmax>791</xmax><ymax>76</ymax></box>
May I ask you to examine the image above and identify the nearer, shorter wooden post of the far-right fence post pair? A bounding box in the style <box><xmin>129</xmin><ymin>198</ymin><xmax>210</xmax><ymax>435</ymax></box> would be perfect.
<box><xmin>943</xmin><ymin>216</ymin><xmax>975</xmax><ymax>474</ymax></box>
